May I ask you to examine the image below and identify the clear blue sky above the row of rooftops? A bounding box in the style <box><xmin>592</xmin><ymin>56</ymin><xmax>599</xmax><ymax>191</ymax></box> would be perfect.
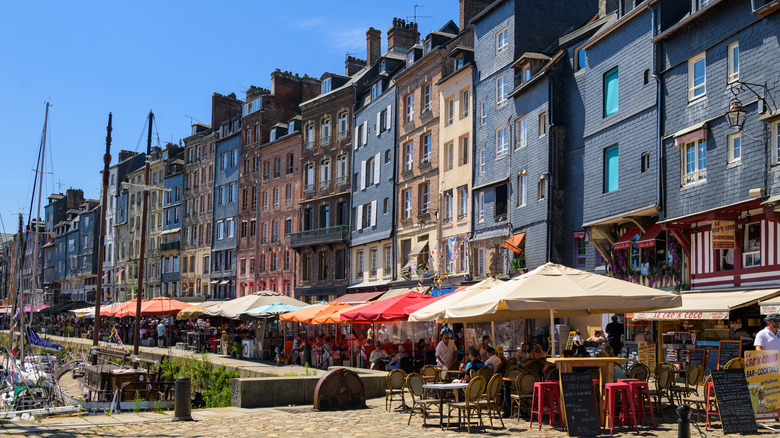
<box><xmin>0</xmin><ymin>0</ymin><xmax>458</xmax><ymax>232</ymax></box>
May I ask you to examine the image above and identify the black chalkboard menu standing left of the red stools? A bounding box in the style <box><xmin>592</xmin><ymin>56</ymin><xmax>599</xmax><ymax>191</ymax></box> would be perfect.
<box><xmin>560</xmin><ymin>373</ymin><xmax>601</xmax><ymax>436</ymax></box>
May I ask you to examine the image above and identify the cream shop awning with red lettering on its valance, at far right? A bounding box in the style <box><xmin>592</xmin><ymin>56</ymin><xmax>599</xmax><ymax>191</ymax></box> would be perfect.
<box><xmin>634</xmin><ymin>288</ymin><xmax>780</xmax><ymax>321</ymax></box>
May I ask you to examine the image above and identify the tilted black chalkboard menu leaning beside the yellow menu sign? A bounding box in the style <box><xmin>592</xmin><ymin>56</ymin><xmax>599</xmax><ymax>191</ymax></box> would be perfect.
<box><xmin>712</xmin><ymin>369</ymin><xmax>758</xmax><ymax>434</ymax></box>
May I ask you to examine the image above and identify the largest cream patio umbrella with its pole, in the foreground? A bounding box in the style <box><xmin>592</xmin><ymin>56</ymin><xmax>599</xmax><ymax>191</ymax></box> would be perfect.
<box><xmin>443</xmin><ymin>263</ymin><xmax>682</xmax><ymax>351</ymax></box>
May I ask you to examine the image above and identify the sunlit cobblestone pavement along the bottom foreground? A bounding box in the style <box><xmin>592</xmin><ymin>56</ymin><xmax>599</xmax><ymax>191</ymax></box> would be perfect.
<box><xmin>2</xmin><ymin>399</ymin><xmax>780</xmax><ymax>438</ymax></box>
